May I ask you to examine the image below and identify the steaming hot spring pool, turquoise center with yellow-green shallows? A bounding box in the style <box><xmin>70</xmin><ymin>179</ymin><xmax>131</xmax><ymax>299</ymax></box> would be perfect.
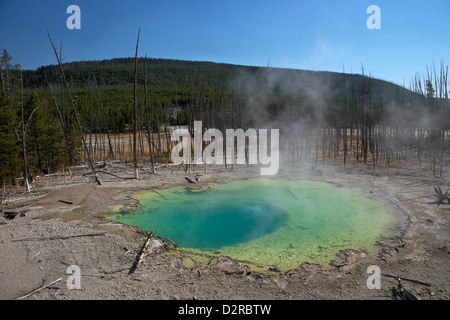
<box><xmin>111</xmin><ymin>178</ymin><xmax>400</xmax><ymax>270</ymax></box>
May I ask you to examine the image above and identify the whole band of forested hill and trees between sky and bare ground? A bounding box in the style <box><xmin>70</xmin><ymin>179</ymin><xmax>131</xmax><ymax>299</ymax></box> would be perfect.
<box><xmin>0</xmin><ymin>50</ymin><xmax>450</xmax><ymax>185</ymax></box>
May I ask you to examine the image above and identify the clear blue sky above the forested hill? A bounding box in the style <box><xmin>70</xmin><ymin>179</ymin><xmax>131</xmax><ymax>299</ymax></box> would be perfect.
<box><xmin>0</xmin><ymin>0</ymin><xmax>450</xmax><ymax>86</ymax></box>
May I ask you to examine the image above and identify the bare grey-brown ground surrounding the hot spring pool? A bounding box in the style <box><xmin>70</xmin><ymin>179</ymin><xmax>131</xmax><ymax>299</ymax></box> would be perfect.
<box><xmin>0</xmin><ymin>165</ymin><xmax>450</xmax><ymax>300</ymax></box>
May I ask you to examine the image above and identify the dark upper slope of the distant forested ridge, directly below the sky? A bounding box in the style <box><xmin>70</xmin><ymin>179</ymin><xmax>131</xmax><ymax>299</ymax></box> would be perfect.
<box><xmin>24</xmin><ymin>58</ymin><xmax>411</xmax><ymax>102</ymax></box>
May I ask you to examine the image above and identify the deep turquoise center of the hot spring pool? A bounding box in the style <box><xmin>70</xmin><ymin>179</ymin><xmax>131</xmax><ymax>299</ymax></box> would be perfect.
<box><xmin>142</xmin><ymin>200</ymin><xmax>287</xmax><ymax>249</ymax></box>
